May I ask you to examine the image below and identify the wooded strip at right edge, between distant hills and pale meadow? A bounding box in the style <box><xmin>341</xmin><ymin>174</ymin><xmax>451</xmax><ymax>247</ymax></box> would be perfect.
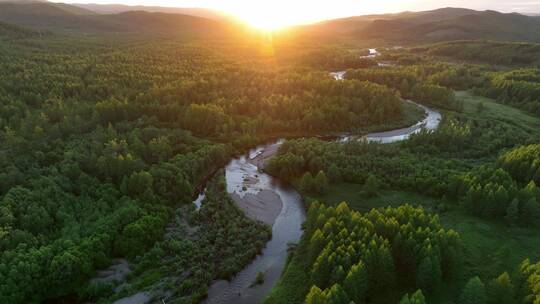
<box><xmin>394</xmin><ymin>41</ymin><xmax>540</xmax><ymax>115</ymax></box>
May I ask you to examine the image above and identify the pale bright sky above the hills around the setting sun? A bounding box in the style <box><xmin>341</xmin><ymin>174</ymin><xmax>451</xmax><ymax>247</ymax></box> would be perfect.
<box><xmin>54</xmin><ymin>0</ymin><xmax>540</xmax><ymax>27</ymax></box>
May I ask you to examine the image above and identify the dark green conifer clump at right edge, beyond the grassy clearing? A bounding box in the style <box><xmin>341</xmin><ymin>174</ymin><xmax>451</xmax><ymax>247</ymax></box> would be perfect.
<box><xmin>449</xmin><ymin>145</ymin><xmax>540</xmax><ymax>227</ymax></box>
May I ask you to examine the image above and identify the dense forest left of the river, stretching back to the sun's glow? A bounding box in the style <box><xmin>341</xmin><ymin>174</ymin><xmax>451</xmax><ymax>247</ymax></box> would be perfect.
<box><xmin>0</xmin><ymin>26</ymin><xmax>412</xmax><ymax>303</ymax></box>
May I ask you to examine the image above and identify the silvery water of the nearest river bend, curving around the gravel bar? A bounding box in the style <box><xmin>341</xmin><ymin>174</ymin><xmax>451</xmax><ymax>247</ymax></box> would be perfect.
<box><xmin>204</xmin><ymin>141</ymin><xmax>305</xmax><ymax>304</ymax></box>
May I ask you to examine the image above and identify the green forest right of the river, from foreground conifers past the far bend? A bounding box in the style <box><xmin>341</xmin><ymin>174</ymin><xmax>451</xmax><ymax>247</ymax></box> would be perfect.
<box><xmin>266</xmin><ymin>45</ymin><xmax>540</xmax><ymax>303</ymax></box>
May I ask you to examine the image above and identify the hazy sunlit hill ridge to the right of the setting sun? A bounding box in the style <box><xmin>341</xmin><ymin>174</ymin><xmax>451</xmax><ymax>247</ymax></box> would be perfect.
<box><xmin>296</xmin><ymin>8</ymin><xmax>540</xmax><ymax>44</ymax></box>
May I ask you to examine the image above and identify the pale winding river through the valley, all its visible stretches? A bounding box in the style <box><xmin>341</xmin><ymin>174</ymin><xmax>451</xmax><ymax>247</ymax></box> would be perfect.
<box><xmin>200</xmin><ymin>49</ymin><xmax>441</xmax><ymax>304</ymax></box>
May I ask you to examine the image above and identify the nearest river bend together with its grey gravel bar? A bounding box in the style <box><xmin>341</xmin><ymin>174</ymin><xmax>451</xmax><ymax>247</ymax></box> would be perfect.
<box><xmin>203</xmin><ymin>141</ymin><xmax>305</xmax><ymax>304</ymax></box>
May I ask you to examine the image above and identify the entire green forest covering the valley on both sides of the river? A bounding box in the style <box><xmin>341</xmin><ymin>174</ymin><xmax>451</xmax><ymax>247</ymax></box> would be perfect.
<box><xmin>0</xmin><ymin>3</ymin><xmax>540</xmax><ymax>304</ymax></box>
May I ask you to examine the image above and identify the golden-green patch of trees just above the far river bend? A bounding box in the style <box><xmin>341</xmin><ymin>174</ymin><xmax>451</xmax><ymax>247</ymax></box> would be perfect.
<box><xmin>346</xmin><ymin>63</ymin><xmax>477</xmax><ymax>111</ymax></box>
